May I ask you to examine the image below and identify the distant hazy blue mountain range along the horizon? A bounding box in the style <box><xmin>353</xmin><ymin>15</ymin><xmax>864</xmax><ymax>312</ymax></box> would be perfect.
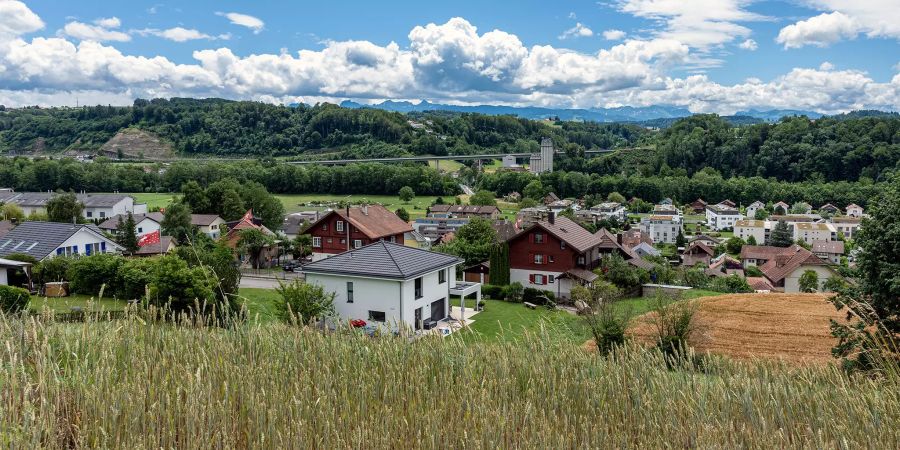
<box><xmin>341</xmin><ymin>100</ymin><xmax>822</xmax><ymax>126</ymax></box>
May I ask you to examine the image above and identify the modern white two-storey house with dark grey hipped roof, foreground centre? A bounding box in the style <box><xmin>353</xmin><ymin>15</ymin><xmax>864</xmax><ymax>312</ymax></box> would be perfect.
<box><xmin>303</xmin><ymin>241</ymin><xmax>481</xmax><ymax>330</ymax></box>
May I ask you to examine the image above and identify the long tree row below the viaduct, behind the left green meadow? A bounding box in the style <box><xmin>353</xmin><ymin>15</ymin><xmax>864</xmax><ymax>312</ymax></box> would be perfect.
<box><xmin>0</xmin><ymin>157</ymin><xmax>461</xmax><ymax>195</ymax></box>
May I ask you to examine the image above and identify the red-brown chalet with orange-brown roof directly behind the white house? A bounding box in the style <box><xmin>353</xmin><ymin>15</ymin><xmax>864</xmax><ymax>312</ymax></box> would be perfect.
<box><xmin>303</xmin><ymin>205</ymin><xmax>413</xmax><ymax>261</ymax></box>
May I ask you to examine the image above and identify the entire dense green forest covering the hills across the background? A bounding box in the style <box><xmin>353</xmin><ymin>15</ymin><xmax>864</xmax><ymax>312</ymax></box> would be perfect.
<box><xmin>0</xmin><ymin>98</ymin><xmax>900</xmax><ymax>182</ymax></box>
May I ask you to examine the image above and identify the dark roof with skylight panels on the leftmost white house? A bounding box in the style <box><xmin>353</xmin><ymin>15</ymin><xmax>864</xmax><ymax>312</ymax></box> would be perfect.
<box><xmin>0</xmin><ymin>222</ymin><xmax>114</xmax><ymax>259</ymax></box>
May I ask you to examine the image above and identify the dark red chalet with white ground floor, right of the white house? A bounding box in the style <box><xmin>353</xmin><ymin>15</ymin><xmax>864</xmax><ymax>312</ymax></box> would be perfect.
<box><xmin>507</xmin><ymin>214</ymin><xmax>604</xmax><ymax>297</ymax></box>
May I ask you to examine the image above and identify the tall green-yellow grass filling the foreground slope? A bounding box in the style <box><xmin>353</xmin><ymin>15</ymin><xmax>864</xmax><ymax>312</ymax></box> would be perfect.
<box><xmin>0</xmin><ymin>315</ymin><xmax>900</xmax><ymax>449</ymax></box>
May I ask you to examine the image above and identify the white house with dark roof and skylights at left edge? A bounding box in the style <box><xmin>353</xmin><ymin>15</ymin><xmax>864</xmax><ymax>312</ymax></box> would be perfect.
<box><xmin>0</xmin><ymin>222</ymin><xmax>122</xmax><ymax>261</ymax></box>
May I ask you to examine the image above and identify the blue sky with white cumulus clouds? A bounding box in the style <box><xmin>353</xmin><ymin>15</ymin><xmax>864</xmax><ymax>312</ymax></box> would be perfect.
<box><xmin>0</xmin><ymin>0</ymin><xmax>900</xmax><ymax>114</ymax></box>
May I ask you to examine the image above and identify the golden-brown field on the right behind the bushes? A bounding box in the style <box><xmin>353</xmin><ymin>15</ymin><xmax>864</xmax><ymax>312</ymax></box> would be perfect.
<box><xmin>630</xmin><ymin>294</ymin><xmax>844</xmax><ymax>364</ymax></box>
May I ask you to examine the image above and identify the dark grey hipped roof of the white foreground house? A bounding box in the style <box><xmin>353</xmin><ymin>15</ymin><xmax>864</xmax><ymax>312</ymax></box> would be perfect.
<box><xmin>303</xmin><ymin>241</ymin><xmax>462</xmax><ymax>280</ymax></box>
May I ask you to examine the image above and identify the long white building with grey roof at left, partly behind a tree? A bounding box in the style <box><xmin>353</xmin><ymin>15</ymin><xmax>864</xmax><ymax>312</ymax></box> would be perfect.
<box><xmin>0</xmin><ymin>191</ymin><xmax>147</xmax><ymax>220</ymax></box>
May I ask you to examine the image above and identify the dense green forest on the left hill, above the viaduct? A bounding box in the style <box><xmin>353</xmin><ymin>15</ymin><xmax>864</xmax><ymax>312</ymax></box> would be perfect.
<box><xmin>0</xmin><ymin>98</ymin><xmax>648</xmax><ymax>157</ymax></box>
